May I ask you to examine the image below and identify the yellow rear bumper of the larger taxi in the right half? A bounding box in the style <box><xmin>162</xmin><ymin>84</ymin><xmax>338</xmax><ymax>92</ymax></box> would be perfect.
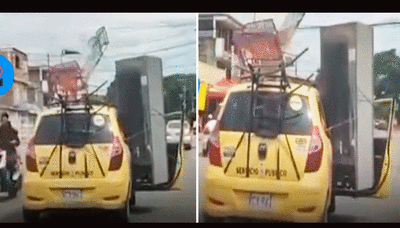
<box><xmin>203</xmin><ymin>165</ymin><xmax>330</xmax><ymax>222</ymax></box>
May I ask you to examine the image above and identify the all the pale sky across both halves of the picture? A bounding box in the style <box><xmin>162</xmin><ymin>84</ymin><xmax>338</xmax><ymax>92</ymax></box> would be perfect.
<box><xmin>0</xmin><ymin>13</ymin><xmax>400</xmax><ymax>94</ymax></box>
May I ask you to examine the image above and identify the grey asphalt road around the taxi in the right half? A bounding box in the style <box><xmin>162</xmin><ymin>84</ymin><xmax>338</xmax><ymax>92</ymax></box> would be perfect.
<box><xmin>198</xmin><ymin>129</ymin><xmax>400</xmax><ymax>223</ymax></box>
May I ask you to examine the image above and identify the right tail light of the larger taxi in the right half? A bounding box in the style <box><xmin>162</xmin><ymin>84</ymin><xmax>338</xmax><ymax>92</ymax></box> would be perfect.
<box><xmin>304</xmin><ymin>126</ymin><xmax>323</xmax><ymax>172</ymax></box>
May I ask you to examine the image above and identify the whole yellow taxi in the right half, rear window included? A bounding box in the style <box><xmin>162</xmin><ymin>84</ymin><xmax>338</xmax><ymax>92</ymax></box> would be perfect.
<box><xmin>203</xmin><ymin>77</ymin><xmax>333</xmax><ymax>222</ymax></box>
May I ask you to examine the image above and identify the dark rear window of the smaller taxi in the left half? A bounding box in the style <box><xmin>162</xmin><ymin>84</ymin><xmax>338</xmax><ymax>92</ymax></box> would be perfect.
<box><xmin>34</xmin><ymin>114</ymin><xmax>112</xmax><ymax>145</ymax></box>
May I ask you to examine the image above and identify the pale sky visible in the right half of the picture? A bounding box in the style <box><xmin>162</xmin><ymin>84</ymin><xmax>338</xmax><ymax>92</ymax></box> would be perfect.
<box><xmin>230</xmin><ymin>13</ymin><xmax>400</xmax><ymax>75</ymax></box>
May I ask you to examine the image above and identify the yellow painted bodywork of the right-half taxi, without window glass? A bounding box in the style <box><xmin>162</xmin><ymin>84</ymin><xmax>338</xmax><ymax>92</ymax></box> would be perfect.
<box><xmin>203</xmin><ymin>78</ymin><xmax>332</xmax><ymax>222</ymax></box>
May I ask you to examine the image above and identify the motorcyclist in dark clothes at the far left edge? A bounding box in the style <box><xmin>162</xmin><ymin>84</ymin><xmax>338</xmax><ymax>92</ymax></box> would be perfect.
<box><xmin>0</xmin><ymin>112</ymin><xmax>20</xmax><ymax>180</ymax></box>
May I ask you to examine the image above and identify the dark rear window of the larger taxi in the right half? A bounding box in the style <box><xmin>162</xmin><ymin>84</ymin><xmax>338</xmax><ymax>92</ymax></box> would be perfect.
<box><xmin>220</xmin><ymin>91</ymin><xmax>312</xmax><ymax>135</ymax></box>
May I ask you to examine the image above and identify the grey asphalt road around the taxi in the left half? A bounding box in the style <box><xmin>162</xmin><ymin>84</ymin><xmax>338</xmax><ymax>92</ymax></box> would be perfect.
<box><xmin>0</xmin><ymin>134</ymin><xmax>196</xmax><ymax>223</ymax></box>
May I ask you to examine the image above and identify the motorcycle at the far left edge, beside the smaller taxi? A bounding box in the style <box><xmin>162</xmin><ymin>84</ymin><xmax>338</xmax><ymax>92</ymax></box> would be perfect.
<box><xmin>0</xmin><ymin>149</ymin><xmax>22</xmax><ymax>198</ymax></box>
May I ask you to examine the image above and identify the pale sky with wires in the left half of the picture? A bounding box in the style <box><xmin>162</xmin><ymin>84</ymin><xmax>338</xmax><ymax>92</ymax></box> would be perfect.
<box><xmin>0</xmin><ymin>13</ymin><xmax>197</xmax><ymax>94</ymax></box>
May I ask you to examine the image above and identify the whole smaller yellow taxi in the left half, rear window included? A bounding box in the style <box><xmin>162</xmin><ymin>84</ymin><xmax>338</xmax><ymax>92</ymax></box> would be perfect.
<box><xmin>22</xmin><ymin>106</ymin><xmax>134</xmax><ymax>221</ymax></box>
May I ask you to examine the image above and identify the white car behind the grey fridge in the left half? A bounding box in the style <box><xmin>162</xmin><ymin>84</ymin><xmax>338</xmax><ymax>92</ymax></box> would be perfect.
<box><xmin>166</xmin><ymin>120</ymin><xmax>192</xmax><ymax>150</ymax></box>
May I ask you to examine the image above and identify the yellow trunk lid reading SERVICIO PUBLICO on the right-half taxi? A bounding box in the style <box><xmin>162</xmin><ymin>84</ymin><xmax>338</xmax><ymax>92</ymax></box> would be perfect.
<box><xmin>220</xmin><ymin>132</ymin><xmax>311</xmax><ymax>181</ymax></box>
